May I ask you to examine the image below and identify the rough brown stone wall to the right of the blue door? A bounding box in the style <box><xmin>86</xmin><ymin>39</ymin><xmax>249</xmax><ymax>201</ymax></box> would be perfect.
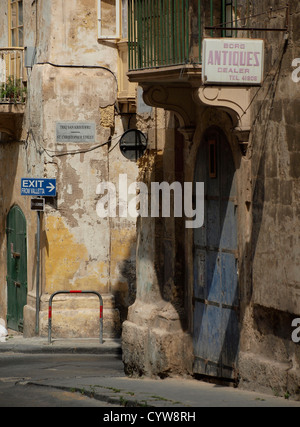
<box><xmin>240</xmin><ymin>2</ymin><xmax>300</xmax><ymax>394</ymax></box>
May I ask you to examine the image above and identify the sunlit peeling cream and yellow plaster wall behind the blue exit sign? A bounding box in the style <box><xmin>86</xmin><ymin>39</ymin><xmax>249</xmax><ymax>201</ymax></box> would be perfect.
<box><xmin>0</xmin><ymin>0</ymin><xmax>137</xmax><ymax>337</ymax></box>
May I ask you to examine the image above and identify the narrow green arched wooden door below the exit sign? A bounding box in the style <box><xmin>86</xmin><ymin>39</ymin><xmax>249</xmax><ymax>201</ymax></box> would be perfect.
<box><xmin>6</xmin><ymin>206</ymin><xmax>27</xmax><ymax>332</ymax></box>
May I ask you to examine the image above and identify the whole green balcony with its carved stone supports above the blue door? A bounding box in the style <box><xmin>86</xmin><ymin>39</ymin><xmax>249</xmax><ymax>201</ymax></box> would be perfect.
<box><xmin>127</xmin><ymin>0</ymin><xmax>250</xmax><ymax>141</ymax></box>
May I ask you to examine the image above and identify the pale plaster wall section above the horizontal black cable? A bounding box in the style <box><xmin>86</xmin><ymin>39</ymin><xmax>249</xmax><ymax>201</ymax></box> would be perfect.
<box><xmin>38</xmin><ymin>0</ymin><xmax>117</xmax><ymax>71</ymax></box>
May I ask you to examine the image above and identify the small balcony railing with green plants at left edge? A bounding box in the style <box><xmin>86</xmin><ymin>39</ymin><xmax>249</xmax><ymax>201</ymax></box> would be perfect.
<box><xmin>0</xmin><ymin>47</ymin><xmax>26</xmax><ymax>104</ymax></box>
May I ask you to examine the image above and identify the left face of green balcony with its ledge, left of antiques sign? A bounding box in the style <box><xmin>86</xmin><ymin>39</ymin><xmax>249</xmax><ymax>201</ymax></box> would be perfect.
<box><xmin>128</xmin><ymin>0</ymin><xmax>202</xmax><ymax>83</ymax></box>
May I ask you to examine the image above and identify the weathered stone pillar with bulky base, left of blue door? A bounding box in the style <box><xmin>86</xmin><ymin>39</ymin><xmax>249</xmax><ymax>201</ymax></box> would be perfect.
<box><xmin>122</xmin><ymin>109</ymin><xmax>193</xmax><ymax>378</ymax></box>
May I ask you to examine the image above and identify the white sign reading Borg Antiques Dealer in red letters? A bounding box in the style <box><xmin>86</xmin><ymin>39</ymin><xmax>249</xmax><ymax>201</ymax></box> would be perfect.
<box><xmin>202</xmin><ymin>38</ymin><xmax>264</xmax><ymax>86</ymax></box>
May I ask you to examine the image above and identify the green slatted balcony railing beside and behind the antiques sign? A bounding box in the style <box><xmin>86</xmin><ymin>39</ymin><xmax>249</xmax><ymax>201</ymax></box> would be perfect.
<box><xmin>128</xmin><ymin>0</ymin><xmax>237</xmax><ymax>71</ymax></box>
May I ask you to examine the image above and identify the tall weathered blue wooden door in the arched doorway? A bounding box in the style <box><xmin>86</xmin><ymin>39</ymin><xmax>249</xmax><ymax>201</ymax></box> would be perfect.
<box><xmin>193</xmin><ymin>130</ymin><xmax>239</xmax><ymax>379</ymax></box>
